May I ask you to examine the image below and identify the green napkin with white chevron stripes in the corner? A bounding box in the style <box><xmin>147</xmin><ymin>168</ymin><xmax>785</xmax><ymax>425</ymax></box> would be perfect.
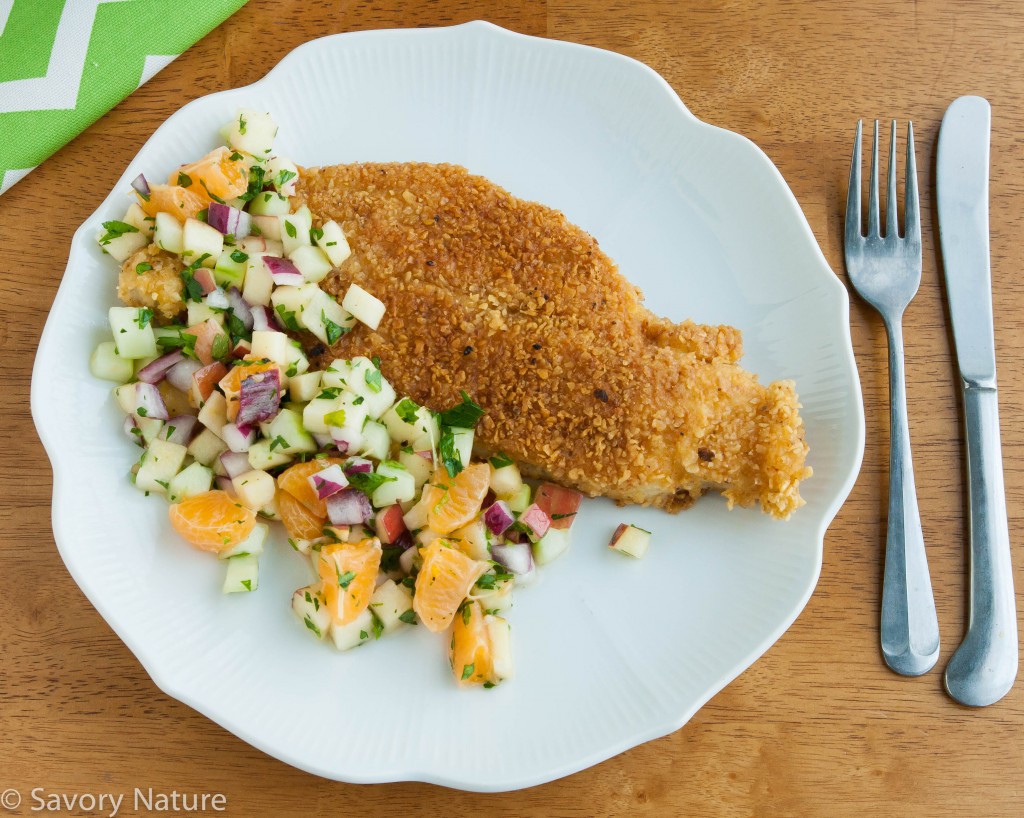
<box><xmin>0</xmin><ymin>0</ymin><xmax>246</xmax><ymax>193</ymax></box>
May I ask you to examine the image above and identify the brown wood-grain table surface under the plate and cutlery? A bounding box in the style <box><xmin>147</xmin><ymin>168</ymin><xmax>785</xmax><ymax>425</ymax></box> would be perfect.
<box><xmin>0</xmin><ymin>0</ymin><xmax>1024</xmax><ymax>816</ymax></box>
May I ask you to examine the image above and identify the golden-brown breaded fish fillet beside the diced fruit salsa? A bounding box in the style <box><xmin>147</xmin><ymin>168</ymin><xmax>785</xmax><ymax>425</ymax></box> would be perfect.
<box><xmin>298</xmin><ymin>163</ymin><xmax>811</xmax><ymax>518</ymax></box>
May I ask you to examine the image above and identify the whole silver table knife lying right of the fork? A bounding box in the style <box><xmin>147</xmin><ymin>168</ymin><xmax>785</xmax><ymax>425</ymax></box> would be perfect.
<box><xmin>936</xmin><ymin>96</ymin><xmax>1018</xmax><ymax>706</ymax></box>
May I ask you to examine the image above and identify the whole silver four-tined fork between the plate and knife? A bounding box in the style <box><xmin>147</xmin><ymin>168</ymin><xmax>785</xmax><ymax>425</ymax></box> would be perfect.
<box><xmin>845</xmin><ymin>120</ymin><xmax>939</xmax><ymax>676</ymax></box>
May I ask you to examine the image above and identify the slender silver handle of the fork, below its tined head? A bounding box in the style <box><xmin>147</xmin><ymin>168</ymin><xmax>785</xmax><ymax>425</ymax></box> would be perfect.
<box><xmin>882</xmin><ymin>317</ymin><xmax>939</xmax><ymax>676</ymax></box>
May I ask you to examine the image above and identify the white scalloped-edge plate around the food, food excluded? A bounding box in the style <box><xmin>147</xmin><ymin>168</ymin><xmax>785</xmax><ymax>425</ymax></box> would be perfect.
<box><xmin>32</xmin><ymin>23</ymin><xmax>864</xmax><ymax>790</ymax></box>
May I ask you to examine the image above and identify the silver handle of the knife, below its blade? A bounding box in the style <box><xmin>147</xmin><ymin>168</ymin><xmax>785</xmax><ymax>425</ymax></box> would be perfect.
<box><xmin>946</xmin><ymin>384</ymin><xmax>1018</xmax><ymax>706</ymax></box>
